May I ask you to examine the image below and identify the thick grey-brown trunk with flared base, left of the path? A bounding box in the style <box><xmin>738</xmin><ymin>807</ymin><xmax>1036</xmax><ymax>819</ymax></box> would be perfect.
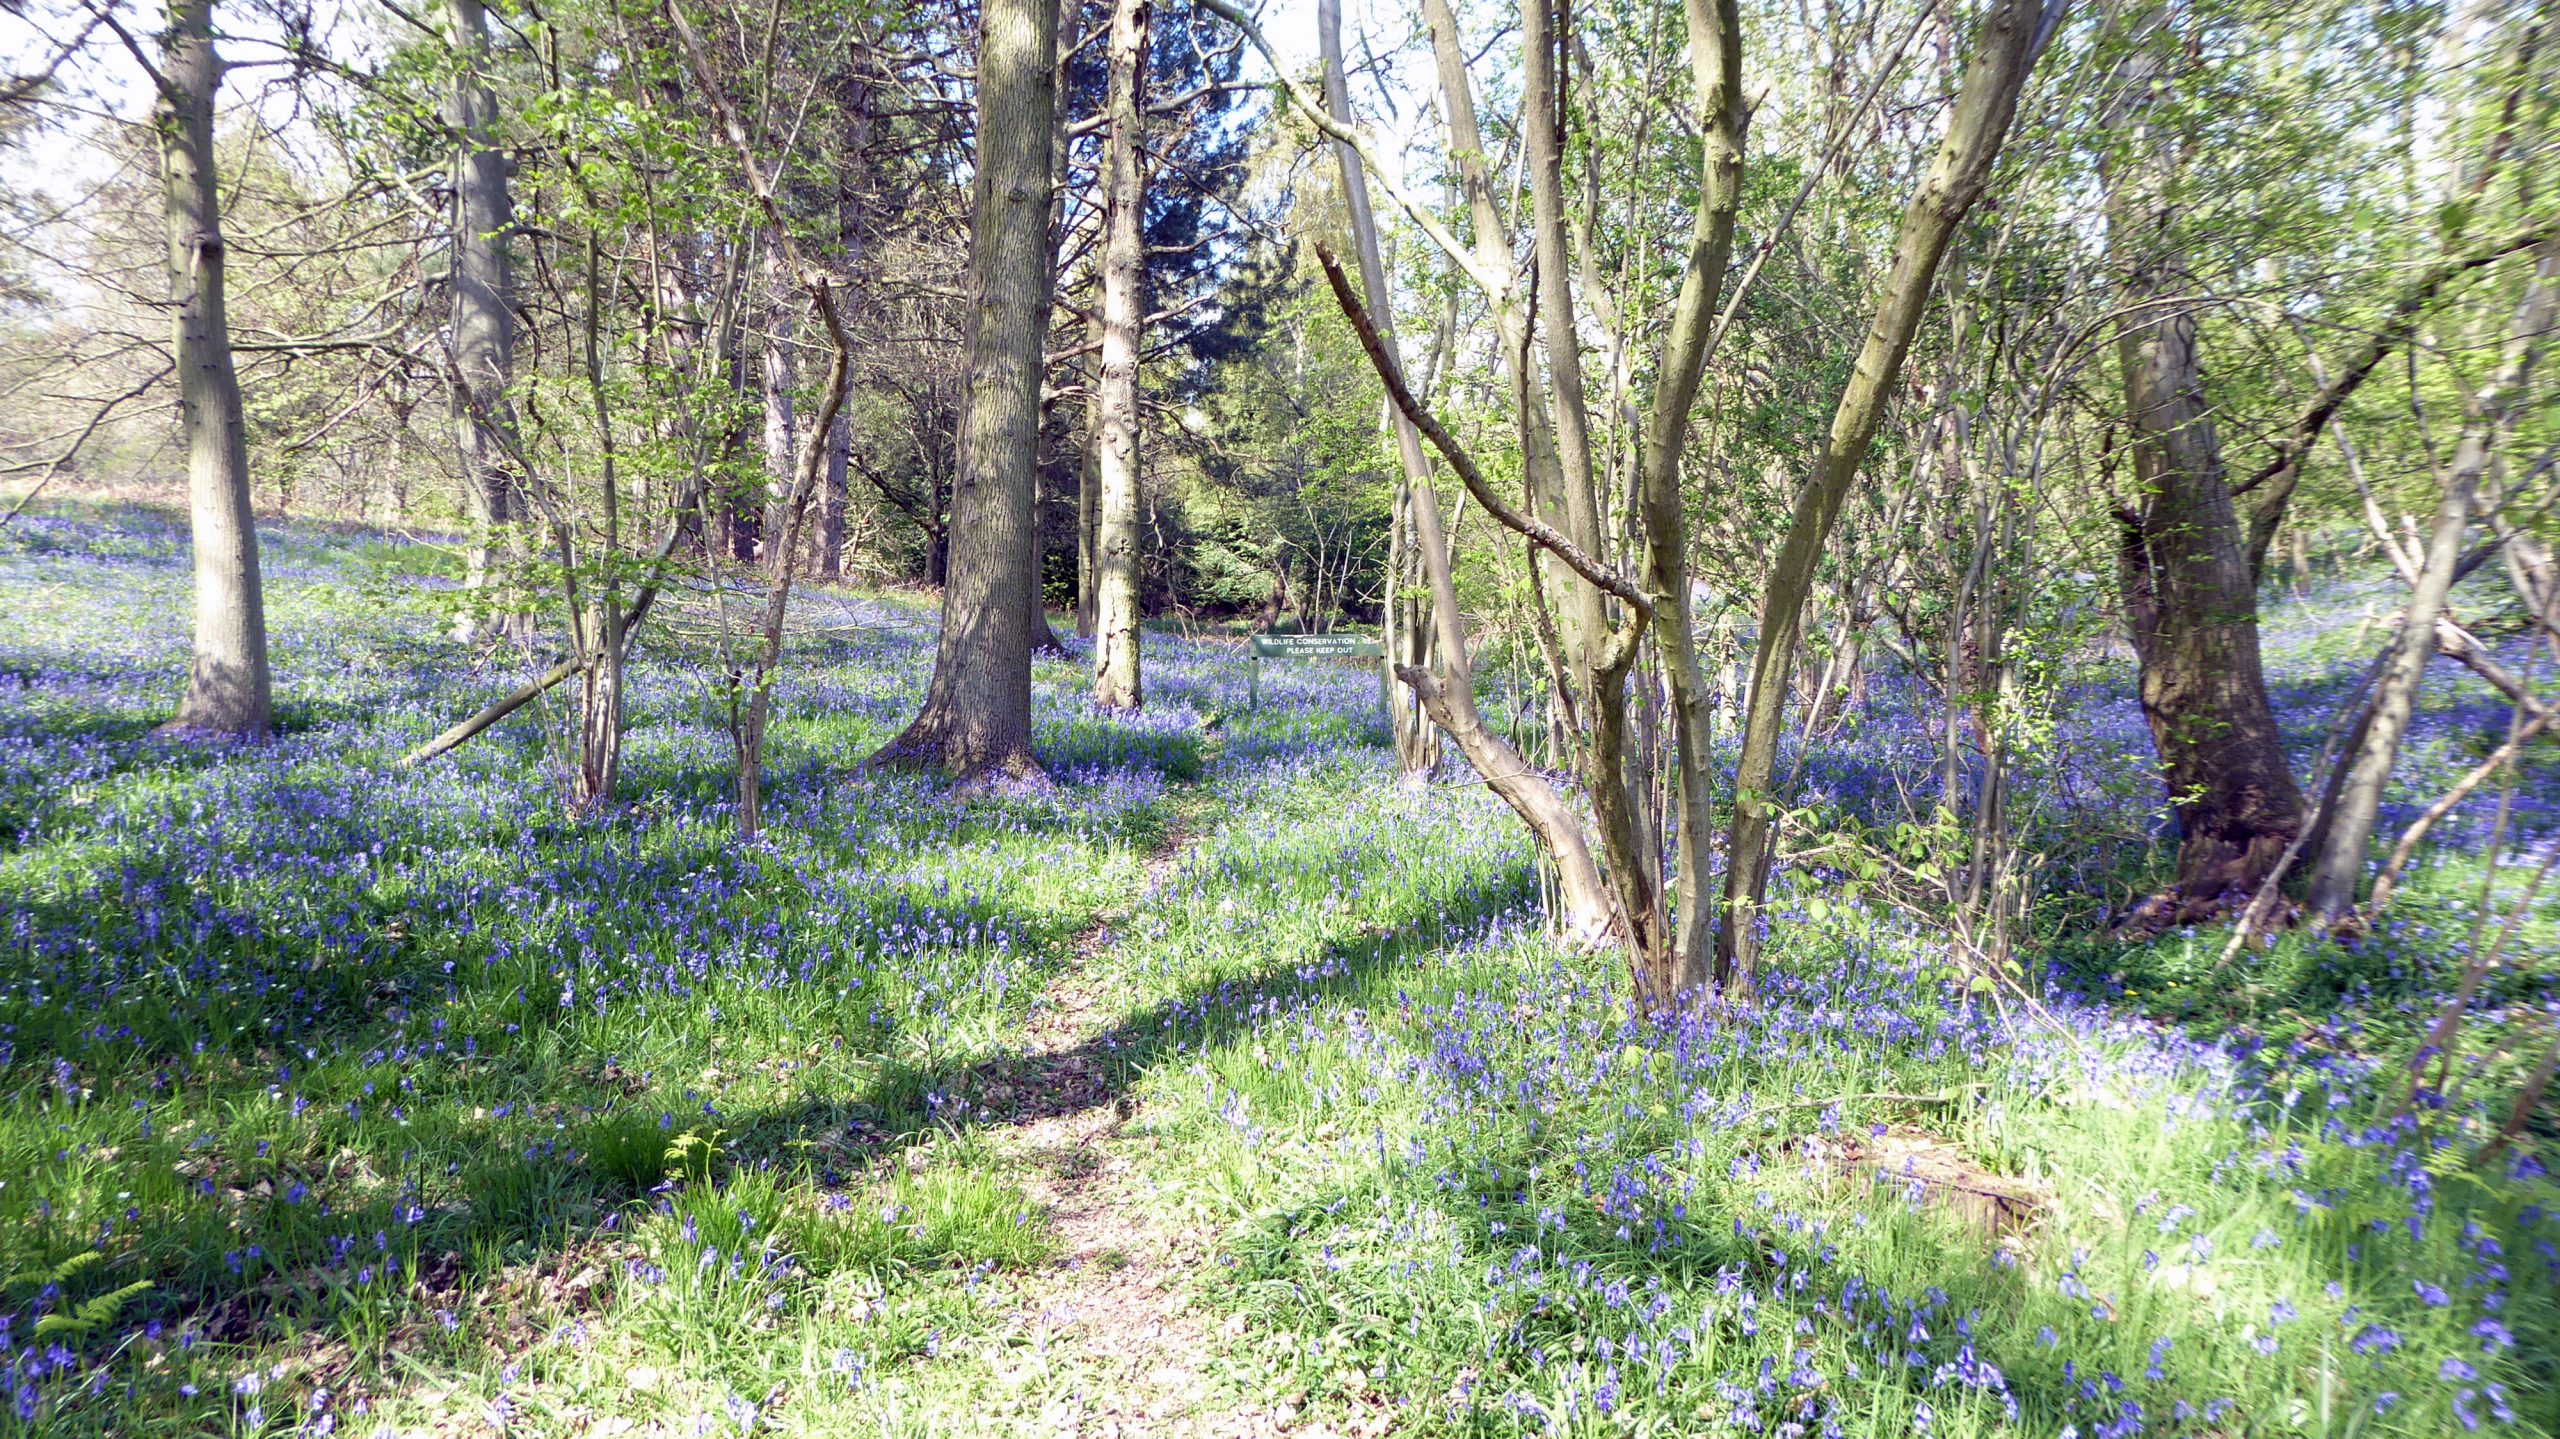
<box><xmin>878</xmin><ymin>0</ymin><xmax>1057</xmax><ymax>784</ymax></box>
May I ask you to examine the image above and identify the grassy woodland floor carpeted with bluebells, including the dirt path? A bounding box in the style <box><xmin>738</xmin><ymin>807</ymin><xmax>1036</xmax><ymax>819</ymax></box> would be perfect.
<box><xmin>0</xmin><ymin>512</ymin><xmax>2560</xmax><ymax>1436</ymax></box>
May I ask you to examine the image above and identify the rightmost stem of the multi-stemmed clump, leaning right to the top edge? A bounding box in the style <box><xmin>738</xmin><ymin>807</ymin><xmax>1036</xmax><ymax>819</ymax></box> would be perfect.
<box><xmin>1715</xmin><ymin>0</ymin><xmax>2066</xmax><ymax>986</ymax></box>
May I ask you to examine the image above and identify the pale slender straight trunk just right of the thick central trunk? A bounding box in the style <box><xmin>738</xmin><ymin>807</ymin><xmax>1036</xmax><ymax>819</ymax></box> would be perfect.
<box><xmin>1093</xmin><ymin>0</ymin><xmax>1152</xmax><ymax>709</ymax></box>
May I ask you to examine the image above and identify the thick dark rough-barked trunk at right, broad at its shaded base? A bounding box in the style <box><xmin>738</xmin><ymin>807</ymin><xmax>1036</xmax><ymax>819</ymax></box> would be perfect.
<box><xmin>2102</xmin><ymin>28</ymin><xmax>2301</xmax><ymax>922</ymax></box>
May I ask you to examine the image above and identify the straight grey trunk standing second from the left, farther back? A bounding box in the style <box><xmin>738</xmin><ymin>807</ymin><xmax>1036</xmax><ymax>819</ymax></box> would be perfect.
<box><xmin>445</xmin><ymin>0</ymin><xmax>520</xmax><ymax>640</ymax></box>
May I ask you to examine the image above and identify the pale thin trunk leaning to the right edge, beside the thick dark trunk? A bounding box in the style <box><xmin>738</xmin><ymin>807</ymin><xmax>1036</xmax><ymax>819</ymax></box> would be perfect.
<box><xmin>2304</xmin><ymin>246</ymin><xmax>2560</xmax><ymax>924</ymax></box>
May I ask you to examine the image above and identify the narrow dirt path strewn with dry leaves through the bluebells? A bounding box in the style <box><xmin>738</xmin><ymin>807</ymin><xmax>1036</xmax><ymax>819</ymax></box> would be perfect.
<box><xmin>967</xmin><ymin>830</ymin><xmax>1318</xmax><ymax>1439</ymax></box>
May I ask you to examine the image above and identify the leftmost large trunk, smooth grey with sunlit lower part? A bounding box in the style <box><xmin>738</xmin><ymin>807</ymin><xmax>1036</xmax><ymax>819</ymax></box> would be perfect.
<box><xmin>154</xmin><ymin>0</ymin><xmax>271</xmax><ymax>740</ymax></box>
